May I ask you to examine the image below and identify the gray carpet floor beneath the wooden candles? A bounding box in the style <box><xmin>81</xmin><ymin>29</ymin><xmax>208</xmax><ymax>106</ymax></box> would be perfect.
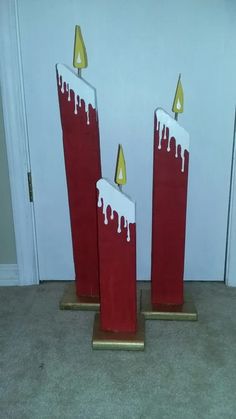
<box><xmin>0</xmin><ymin>282</ymin><xmax>236</xmax><ymax>419</ymax></box>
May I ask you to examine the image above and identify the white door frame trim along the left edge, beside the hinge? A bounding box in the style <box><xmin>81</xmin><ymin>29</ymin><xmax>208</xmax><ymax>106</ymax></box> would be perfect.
<box><xmin>0</xmin><ymin>0</ymin><xmax>39</xmax><ymax>285</ymax></box>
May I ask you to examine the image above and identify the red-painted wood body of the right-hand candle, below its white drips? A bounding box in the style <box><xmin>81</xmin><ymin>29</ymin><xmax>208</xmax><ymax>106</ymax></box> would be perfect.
<box><xmin>151</xmin><ymin>115</ymin><xmax>189</xmax><ymax>305</ymax></box>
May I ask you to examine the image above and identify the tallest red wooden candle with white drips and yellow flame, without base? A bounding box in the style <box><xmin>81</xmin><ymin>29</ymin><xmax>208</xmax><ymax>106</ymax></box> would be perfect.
<box><xmin>56</xmin><ymin>26</ymin><xmax>101</xmax><ymax>297</ymax></box>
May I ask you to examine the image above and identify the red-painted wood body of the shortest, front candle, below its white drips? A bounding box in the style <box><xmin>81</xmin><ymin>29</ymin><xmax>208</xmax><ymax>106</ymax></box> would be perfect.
<box><xmin>97</xmin><ymin>202</ymin><xmax>137</xmax><ymax>332</ymax></box>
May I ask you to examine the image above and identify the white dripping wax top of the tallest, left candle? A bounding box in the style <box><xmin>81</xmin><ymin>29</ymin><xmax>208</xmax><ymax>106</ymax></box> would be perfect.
<box><xmin>56</xmin><ymin>64</ymin><xmax>96</xmax><ymax>125</ymax></box>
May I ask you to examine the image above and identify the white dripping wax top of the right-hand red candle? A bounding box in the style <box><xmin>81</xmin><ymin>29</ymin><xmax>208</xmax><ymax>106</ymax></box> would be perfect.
<box><xmin>156</xmin><ymin>108</ymin><xmax>189</xmax><ymax>172</ymax></box>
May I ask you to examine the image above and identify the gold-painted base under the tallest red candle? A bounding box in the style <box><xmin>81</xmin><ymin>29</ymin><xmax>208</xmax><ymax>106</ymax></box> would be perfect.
<box><xmin>59</xmin><ymin>283</ymin><xmax>100</xmax><ymax>311</ymax></box>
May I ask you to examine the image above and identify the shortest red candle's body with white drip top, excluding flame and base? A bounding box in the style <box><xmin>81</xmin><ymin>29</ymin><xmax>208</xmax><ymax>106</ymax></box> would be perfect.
<box><xmin>97</xmin><ymin>179</ymin><xmax>137</xmax><ymax>332</ymax></box>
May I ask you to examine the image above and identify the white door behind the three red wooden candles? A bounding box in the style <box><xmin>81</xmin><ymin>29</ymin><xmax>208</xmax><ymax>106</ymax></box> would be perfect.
<box><xmin>19</xmin><ymin>0</ymin><xmax>236</xmax><ymax>279</ymax></box>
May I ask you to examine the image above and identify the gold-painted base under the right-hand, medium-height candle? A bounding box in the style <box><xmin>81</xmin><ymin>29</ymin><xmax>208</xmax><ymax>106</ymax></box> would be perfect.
<box><xmin>140</xmin><ymin>290</ymin><xmax>197</xmax><ymax>321</ymax></box>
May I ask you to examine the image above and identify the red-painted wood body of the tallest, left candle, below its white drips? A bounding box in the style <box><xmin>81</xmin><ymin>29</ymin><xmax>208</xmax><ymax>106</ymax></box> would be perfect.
<box><xmin>57</xmin><ymin>74</ymin><xmax>101</xmax><ymax>296</ymax></box>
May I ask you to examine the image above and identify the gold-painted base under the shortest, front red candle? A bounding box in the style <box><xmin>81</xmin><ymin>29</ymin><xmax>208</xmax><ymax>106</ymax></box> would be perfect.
<box><xmin>92</xmin><ymin>313</ymin><xmax>145</xmax><ymax>351</ymax></box>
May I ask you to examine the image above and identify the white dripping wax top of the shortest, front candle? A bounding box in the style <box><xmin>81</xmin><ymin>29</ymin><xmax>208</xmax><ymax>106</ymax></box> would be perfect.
<box><xmin>97</xmin><ymin>179</ymin><xmax>135</xmax><ymax>242</ymax></box>
